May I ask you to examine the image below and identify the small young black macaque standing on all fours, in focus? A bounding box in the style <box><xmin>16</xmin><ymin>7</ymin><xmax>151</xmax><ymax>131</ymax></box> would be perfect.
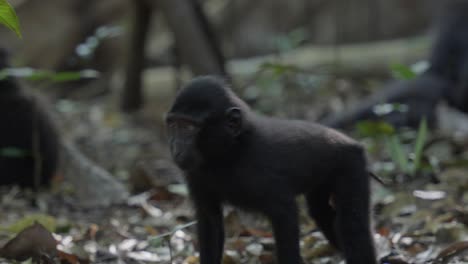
<box><xmin>166</xmin><ymin>76</ymin><xmax>377</xmax><ymax>264</ymax></box>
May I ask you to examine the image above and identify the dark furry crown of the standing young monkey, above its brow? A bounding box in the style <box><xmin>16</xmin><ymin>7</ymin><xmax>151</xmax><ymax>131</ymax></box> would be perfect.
<box><xmin>170</xmin><ymin>76</ymin><xmax>250</xmax><ymax>117</ymax></box>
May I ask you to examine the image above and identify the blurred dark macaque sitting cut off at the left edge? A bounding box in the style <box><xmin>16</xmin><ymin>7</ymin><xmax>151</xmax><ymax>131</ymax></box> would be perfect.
<box><xmin>0</xmin><ymin>49</ymin><xmax>59</xmax><ymax>188</ymax></box>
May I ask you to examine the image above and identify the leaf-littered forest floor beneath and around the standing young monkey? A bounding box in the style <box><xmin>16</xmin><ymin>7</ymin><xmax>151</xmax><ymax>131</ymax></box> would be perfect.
<box><xmin>0</xmin><ymin>72</ymin><xmax>468</xmax><ymax>264</ymax></box>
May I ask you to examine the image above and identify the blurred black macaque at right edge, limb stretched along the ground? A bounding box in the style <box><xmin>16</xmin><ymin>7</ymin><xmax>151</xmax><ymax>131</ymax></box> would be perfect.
<box><xmin>321</xmin><ymin>0</ymin><xmax>468</xmax><ymax>128</ymax></box>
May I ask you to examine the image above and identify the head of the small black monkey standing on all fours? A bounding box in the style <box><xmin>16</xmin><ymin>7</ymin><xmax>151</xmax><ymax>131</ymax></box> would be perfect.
<box><xmin>166</xmin><ymin>76</ymin><xmax>248</xmax><ymax>170</ymax></box>
